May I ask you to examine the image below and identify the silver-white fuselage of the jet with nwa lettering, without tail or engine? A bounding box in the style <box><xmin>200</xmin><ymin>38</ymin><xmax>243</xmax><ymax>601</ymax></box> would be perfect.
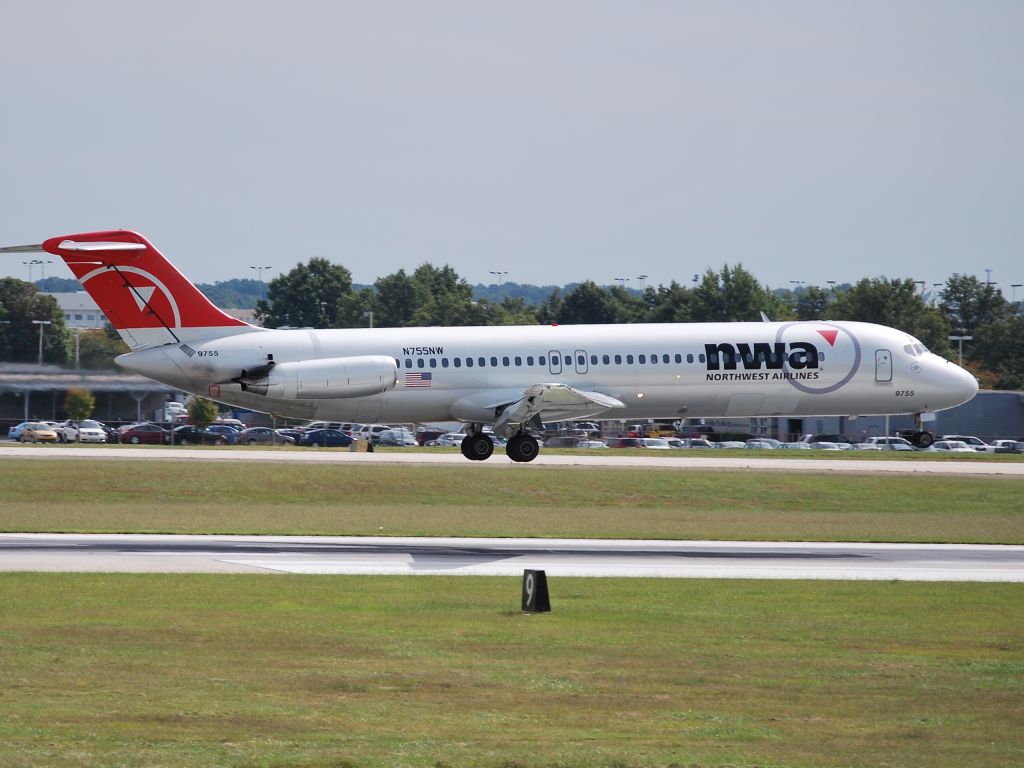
<box><xmin>118</xmin><ymin>322</ymin><xmax>978</xmax><ymax>424</ymax></box>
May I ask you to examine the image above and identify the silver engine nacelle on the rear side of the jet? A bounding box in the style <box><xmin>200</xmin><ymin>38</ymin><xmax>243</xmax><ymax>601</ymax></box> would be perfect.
<box><xmin>232</xmin><ymin>354</ymin><xmax>398</xmax><ymax>400</ymax></box>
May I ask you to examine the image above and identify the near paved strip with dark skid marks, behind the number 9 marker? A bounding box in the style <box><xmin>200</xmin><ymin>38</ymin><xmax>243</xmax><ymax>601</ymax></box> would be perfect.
<box><xmin>0</xmin><ymin>534</ymin><xmax>1024</xmax><ymax>582</ymax></box>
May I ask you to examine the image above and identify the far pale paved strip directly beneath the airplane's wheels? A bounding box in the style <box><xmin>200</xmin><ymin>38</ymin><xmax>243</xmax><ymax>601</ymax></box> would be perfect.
<box><xmin>6</xmin><ymin>443</ymin><xmax>1024</xmax><ymax>477</ymax></box>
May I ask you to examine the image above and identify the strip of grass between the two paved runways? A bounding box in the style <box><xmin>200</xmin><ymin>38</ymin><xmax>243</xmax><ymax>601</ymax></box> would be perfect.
<box><xmin>0</xmin><ymin>460</ymin><xmax>1024</xmax><ymax>544</ymax></box>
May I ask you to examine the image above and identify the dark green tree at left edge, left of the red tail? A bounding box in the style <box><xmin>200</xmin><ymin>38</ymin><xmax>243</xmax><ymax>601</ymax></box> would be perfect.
<box><xmin>0</xmin><ymin>278</ymin><xmax>69</xmax><ymax>365</ymax></box>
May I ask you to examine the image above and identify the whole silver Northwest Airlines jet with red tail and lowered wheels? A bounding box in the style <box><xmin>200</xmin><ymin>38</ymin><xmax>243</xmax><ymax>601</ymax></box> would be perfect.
<box><xmin>0</xmin><ymin>229</ymin><xmax>978</xmax><ymax>462</ymax></box>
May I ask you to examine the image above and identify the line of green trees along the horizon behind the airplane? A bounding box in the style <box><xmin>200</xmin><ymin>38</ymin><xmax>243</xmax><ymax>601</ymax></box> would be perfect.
<box><xmin>0</xmin><ymin>264</ymin><xmax>1024</xmax><ymax>389</ymax></box>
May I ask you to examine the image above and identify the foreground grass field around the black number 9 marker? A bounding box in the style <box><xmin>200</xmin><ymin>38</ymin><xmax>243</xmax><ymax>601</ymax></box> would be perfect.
<box><xmin>0</xmin><ymin>573</ymin><xmax>1024</xmax><ymax>768</ymax></box>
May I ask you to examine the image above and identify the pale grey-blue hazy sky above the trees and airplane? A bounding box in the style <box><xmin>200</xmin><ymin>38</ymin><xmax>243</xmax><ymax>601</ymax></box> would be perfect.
<box><xmin>0</xmin><ymin>0</ymin><xmax>1024</xmax><ymax>298</ymax></box>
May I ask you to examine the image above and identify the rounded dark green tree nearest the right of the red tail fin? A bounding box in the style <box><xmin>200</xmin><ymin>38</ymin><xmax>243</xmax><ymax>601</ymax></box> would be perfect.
<box><xmin>256</xmin><ymin>257</ymin><xmax>352</xmax><ymax>328</ymax></box>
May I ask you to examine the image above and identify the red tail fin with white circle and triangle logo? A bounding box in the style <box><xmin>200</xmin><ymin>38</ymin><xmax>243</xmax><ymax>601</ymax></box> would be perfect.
<box><xmin>43</xmin><ymin>229</ymin><xmax>257</xmax><ymax>349</ymax></box>
